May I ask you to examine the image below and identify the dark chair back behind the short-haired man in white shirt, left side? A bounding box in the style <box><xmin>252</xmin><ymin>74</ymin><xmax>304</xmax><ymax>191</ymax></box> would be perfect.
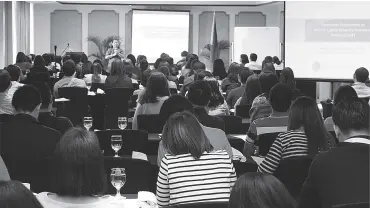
<box><xmin>58</xmin><ymin>87</ymin><xmax>88</xmax><ymax>126</ymax></box>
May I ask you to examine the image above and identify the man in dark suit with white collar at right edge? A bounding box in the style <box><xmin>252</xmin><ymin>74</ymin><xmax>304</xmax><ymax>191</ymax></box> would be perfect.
<box><xmin>299</xmin><ymin>98</ymin><xmax>370</xmax><ymax>208</ymax></box>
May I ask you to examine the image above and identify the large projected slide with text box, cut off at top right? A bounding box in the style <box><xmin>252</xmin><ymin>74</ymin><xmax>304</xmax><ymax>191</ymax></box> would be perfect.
<box><xmin>285</xmin><ymin>1</ymin><xmax>370</xmax><ymax>79</ymax></box>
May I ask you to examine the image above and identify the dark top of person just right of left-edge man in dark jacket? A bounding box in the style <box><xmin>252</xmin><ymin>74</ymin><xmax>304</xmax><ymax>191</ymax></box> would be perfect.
<box><xmin>38</xmin><ymin>112</ymin><xmax>73</xmax><ymax>134</ymax></box>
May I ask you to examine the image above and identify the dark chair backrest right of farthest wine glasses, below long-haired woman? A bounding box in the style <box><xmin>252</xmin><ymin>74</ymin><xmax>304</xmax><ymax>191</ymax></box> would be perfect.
<box><xmin>137</xmin><ymin>114</ymin><xmax>164</xmax><ymax>133</ymax></box>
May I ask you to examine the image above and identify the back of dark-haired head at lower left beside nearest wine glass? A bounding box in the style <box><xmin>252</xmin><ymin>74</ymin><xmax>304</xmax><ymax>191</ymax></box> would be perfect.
<box><xmin>52</xmin><ymin>128</ymin><xmax>107</xmax><ymax>197</ymax></box>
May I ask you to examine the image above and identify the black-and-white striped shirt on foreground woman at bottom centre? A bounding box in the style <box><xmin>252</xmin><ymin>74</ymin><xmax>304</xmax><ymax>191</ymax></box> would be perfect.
<box><xmin>157</xmin><ymin>150</ymin><xmax>236</xmax><ymax>206</ymax></box>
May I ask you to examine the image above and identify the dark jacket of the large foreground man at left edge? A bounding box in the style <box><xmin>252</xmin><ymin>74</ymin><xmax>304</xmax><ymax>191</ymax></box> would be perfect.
<box><xmin>1</xmin><ymin>114</ymin><xmax>61</xmax><ymax>159</ymax></box>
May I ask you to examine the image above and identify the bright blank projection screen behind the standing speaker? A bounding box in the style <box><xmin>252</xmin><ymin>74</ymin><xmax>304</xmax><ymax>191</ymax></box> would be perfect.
<box><xmin>132</xmin><ymin>10</ymin><xmax>189</xmax><ymax>63</ymax></box>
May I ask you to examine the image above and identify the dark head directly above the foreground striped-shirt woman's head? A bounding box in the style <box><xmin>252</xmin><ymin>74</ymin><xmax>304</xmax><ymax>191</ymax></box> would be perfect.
<box><xmin>159</xmin><ymin>95</ymin><xmax>194</xmax><ymax>122</ymax></box>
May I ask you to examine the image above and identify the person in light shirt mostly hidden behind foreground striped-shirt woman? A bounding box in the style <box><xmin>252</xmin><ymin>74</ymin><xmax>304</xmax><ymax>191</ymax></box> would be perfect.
<box><xmin>157</xmin><ymin>95</ymin><xmax>233</xmax><ymax>166</ymax></box>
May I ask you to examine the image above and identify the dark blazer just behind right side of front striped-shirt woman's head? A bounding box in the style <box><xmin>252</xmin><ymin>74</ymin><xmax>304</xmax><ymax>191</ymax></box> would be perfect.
<box><xmin>194</xmin><ymin>108</ymin><xmax>225</xmax><ymax>131</ymax></box>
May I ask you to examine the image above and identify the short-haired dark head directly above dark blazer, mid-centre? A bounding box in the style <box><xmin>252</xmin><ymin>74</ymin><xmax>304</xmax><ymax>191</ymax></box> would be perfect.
<box><xmin>188</xmin><ymin>80</ymin><xmax>212</xmax><ymax>107</ymax></box>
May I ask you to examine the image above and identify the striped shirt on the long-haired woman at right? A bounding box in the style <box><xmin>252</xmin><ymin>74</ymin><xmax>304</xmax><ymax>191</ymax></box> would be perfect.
<box><xmin>258</xmin><ymin>130</ymin><xmax>308</xmax><ymax>174</ymax></box>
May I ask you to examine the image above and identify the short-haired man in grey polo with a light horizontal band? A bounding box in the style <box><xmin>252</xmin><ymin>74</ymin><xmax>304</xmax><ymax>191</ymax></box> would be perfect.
<box><xmin>244</xmin><ymin>84</ymin><xmax>292</xmax><ymax>156</ymax></box>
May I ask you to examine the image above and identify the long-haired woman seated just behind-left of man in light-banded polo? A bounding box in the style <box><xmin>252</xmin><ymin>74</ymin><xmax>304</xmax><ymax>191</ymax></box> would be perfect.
<box><xmin>234</xmin><ymin>74</ymin><xmax>261</xmax><ymax>109</ymax></box>
